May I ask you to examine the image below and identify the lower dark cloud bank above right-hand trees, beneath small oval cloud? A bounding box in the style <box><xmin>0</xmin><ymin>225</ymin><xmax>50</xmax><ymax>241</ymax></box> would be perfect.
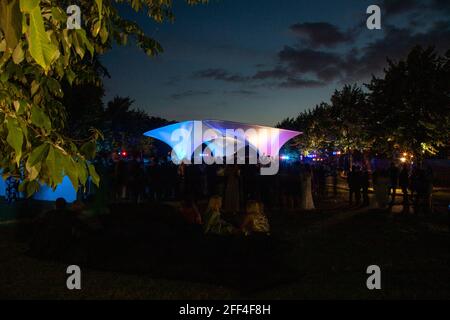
<box><xmin>254</xmin><ymin>13</ymin><xmax>450</xmax><ymax>88</ymax></box>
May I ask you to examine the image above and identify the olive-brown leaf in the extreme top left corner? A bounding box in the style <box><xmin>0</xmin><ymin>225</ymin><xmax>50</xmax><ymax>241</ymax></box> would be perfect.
<box><xmin>0</xmin><ymin>0</ymin><xmax>22</xmax><ymax>50</ymax></box>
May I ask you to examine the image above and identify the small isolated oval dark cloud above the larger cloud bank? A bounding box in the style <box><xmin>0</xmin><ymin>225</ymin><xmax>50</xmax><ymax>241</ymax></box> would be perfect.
<box><xmin>290</xmin><ymin>22</ymin><xmax>355</xmax><ymax>48</ymax></box>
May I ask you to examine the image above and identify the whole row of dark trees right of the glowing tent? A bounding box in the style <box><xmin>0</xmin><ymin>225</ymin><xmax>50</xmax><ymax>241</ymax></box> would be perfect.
<box><xmin>279</xmin><ymin>46</ymin><xmax>450</xmax><ymax>158</ymax></box>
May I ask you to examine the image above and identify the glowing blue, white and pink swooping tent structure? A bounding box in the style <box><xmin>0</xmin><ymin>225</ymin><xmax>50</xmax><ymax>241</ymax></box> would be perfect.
<box><xmin>144</xmin><ymin>120</ymin><xmax>302</xmax><ymax>159</ymax></box>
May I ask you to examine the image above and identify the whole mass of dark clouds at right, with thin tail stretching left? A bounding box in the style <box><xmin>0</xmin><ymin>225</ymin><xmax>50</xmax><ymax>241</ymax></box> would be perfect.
<box><xmin>194</xmin><ymin>9</ymin><xmax>450</xmax><ymax>88</ymax></box>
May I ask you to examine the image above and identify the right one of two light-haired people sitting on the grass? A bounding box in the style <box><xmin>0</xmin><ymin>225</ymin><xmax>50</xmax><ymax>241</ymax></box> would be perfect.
<box><xmin>241</xmin><ymin>201</ymin><xmax>270</xmax><ymax>235</ymax></box>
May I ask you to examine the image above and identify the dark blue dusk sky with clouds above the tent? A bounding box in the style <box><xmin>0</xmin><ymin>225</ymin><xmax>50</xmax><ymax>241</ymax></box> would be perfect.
<box><xmin>102</xmin><ymin>0</ymin><xmax>450</xmax><ymax>125</ymax></box>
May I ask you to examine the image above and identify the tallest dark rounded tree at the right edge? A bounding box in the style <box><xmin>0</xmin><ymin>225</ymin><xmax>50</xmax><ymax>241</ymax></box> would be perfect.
<box><xmin>367</xmin><ymin>46</ymin><xmax>450</xmax><ymax>157</ymax></box>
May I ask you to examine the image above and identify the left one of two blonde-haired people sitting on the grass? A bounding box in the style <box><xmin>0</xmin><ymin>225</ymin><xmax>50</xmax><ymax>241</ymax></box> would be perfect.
<box><xmin>203</xmin><ymin>196</ymin><xmax>235</xmax><ymax>235</ymax></box>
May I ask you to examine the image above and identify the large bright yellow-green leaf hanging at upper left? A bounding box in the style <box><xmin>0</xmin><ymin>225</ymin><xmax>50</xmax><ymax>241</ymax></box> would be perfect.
<box><xmin>27</xmin><ymin>6</ymin><xmax>60</xmax><ymax>72</ymax></box>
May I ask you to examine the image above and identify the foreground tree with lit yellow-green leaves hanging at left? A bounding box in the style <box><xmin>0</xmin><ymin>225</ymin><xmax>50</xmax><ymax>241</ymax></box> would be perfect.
<box><xmin>0</xmin><ymin>0</ymin><xmax>205</xmax><ymax>195</ymax></box>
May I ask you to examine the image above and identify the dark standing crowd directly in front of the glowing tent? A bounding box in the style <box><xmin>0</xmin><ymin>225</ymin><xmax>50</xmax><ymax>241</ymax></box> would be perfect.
<box><xmin>99</xmin><ymin>157</ymin><xmax>338</xmax><ymax>213</ymax></box>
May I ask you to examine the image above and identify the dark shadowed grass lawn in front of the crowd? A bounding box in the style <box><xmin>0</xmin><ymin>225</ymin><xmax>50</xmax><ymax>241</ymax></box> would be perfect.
<box><xmin>0</xmin><ymin>196</ymin><xmax>450</xmax><ymax>299</ymax></box>
